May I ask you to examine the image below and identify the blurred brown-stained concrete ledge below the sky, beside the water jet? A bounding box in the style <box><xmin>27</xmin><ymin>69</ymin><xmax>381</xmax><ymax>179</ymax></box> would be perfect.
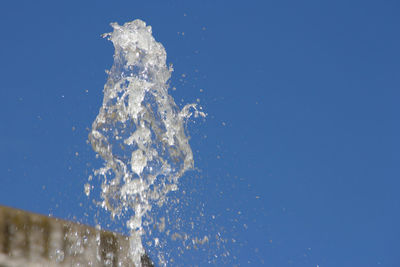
<box><xmin>0</xmin><ymin>206</ymin><xmax>153</xmax><ymax>267</ymax></box>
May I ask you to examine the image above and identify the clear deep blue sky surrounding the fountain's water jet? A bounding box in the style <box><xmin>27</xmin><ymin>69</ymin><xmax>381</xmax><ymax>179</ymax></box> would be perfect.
<box><xmin>0</xmin><ymin>0</ymin><xmax>400</xmax><ymax>267</ymax></box>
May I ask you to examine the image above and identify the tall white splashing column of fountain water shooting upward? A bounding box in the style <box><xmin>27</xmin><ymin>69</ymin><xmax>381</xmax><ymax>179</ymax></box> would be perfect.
<box><xmin>85</xmin><ymin>20</ymin><xmax>205</xmax><ymax>266</ymax></box>
